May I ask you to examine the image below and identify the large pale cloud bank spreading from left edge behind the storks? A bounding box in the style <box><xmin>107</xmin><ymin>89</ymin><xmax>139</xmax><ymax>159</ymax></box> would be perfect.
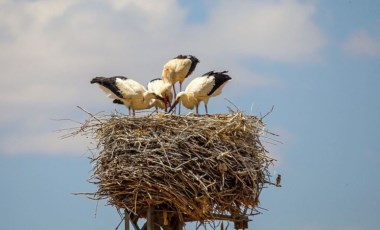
<box><xmin>0</xmin><ymin>0</ymin><xmax>326</xmax><ymax>154</ymax></box>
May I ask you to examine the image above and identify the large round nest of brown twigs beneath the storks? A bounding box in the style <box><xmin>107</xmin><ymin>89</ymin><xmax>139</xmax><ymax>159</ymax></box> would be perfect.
<box><xmin>71</xmin><ymin>112</ymin><xmax>274</xmax><ymax>226</ymax></box>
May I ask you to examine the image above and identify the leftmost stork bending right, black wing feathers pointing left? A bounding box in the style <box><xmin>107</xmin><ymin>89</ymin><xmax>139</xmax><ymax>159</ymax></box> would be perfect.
<box><xmin>91</xmin><ymin>76</ymin><xmax>163</xmax><ymax>115</ymax></box>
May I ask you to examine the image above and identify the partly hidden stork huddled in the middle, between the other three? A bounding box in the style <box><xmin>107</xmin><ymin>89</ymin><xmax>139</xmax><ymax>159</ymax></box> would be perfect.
<box><xmin>148</xmin><ymin>78</ymin><xmax>173</xmax><ymax>112</ymax></box>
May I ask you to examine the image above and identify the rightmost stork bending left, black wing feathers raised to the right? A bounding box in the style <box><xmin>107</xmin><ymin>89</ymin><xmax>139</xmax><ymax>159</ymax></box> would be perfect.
<box><xmin>169</xmin><ymin>71</ymin><xmax>231</xmax><ymax>114</ymax></box>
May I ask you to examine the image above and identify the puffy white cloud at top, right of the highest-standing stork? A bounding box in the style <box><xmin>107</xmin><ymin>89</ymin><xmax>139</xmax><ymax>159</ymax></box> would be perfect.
<box><xmin>189</xmin><ymin>0</ymin><xmax>326</xmax><ymax>61</ymax></box>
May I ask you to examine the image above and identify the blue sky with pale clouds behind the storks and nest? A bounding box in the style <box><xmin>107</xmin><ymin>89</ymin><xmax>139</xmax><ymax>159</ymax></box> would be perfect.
<box><xmin>0</xmin><ymin>0</ymin><xmax>380</xmax><ymax>230</ymax></box>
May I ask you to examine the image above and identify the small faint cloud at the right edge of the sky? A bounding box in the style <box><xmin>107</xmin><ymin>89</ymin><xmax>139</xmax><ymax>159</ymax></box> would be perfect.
<box><xmin>343</xmin><ymin>30</ymin><xmax>380</xmax><ymax>56</ymax></box>
